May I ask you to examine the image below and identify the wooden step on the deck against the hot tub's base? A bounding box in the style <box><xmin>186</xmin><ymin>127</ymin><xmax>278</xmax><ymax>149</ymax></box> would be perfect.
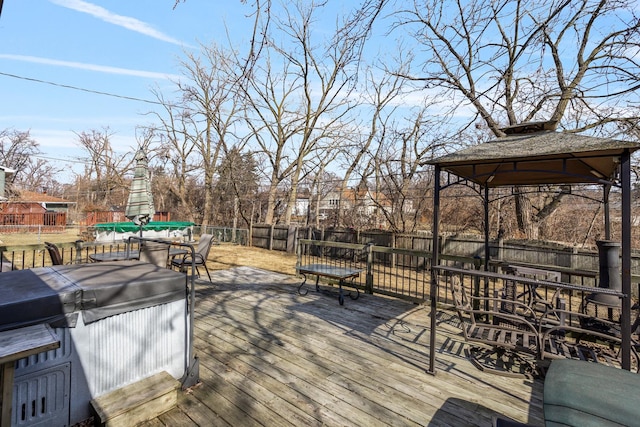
<box><xmin>91</xmin><ymin>371</ymin><xmax>180</xmax><ymax>427</ymax></box>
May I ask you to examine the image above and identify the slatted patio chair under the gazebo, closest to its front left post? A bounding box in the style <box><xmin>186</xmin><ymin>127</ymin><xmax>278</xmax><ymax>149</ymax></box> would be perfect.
<box><xmin>451</xmin><ymin>276</ymin><xmax>539</xmax><ymax>377</ymax></box>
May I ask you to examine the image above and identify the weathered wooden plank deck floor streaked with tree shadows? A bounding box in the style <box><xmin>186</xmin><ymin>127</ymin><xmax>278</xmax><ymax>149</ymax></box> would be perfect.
<box><xmin>145</xmin><ymin>267</ymin><xmax>543</xmax><ymax>427</ymax></box>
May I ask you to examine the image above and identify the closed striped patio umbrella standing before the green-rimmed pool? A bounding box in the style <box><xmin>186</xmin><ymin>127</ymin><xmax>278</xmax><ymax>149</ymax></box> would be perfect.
<box><xmin>124</xmin><ymin>149</ymin><xmax>156</xmax><ymax>237</ymax></box>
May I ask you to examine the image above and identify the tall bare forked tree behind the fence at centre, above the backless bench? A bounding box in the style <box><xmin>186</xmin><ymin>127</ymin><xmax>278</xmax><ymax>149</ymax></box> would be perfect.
<box><xmin>236</xmin><ymin>0</ymin><xmax>379</xmax><ymax>223</ymax></box>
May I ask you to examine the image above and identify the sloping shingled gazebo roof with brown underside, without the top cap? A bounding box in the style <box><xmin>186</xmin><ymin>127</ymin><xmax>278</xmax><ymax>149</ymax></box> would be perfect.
<box><xmin>428</xmin><ymin>131</ymin><xmax>640</xmax><ymax>187</ymax></box>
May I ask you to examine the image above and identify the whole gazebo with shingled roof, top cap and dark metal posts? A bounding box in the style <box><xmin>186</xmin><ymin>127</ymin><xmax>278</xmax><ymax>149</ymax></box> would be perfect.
<box><xmin>429</xmin><ymin>123</ymin><xmax>640</xmax><ymax>370</ymax></box>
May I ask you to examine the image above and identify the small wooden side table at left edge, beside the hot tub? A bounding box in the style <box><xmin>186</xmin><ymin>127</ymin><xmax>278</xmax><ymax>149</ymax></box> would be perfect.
<box><xmin>0</xmin><ymin>324</ymin><xmax>60</xmax><ymax>426</ymax></box>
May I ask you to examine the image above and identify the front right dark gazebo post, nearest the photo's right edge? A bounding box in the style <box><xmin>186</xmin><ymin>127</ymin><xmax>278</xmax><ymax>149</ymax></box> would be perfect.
<box><xmin>620</xmin><ymin>149</ymin><xmax>631</xmax><ymax>371</ymax></box>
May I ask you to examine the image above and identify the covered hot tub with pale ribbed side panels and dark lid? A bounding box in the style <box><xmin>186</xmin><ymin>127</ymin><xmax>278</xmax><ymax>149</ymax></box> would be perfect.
<box><xmin>0</xmin><ymin>261</ymin><xmax>189</xmax><ymax>426</ymax></box>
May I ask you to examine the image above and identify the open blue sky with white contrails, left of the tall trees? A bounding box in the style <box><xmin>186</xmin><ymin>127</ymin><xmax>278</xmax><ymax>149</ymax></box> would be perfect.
<box><xmin>0</xmin><ymin>0</ymin><xmax>255</xmax><ymax>182</ymax></box>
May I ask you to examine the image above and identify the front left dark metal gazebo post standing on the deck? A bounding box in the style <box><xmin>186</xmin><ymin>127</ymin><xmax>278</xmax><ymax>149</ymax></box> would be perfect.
<box><xmin>429</xmin><ymin>165</ymin><xmax>440</xmax><ymax>375</ymax></box>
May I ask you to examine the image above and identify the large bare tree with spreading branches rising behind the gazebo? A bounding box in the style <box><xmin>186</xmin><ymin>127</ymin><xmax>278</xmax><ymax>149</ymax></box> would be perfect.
<box><xmin>397</xmin><ymin>0</ymin><xmax>640</xmax><ymax>238</ymax></box>
